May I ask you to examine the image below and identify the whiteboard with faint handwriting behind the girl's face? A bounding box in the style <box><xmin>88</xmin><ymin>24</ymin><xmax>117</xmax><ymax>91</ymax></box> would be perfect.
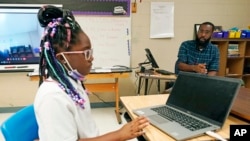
<box><xmin>75</xmin><ymin>15</ymin><xmax>131</xmax><ymax>67</ymax></box>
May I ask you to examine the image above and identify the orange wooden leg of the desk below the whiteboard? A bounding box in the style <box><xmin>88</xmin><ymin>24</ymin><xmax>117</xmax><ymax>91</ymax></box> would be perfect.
<box><xmin>115</xmin><ymin>78</ymin><xmax>122</xmax><ymax>124</ymax></box>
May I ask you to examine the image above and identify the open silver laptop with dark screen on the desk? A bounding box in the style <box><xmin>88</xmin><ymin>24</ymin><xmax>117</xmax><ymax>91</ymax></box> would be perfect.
<box><xmin>133</xmin><ymin>72</ymin><xmax>241</xmax><ymax>140</ymax></box>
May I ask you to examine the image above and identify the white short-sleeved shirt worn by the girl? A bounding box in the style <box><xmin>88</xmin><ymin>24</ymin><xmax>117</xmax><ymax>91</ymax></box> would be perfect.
<box><xmin>34</xmin><ymin>79</ymin><xmax>99</xmax><ymax>141</ymax></box>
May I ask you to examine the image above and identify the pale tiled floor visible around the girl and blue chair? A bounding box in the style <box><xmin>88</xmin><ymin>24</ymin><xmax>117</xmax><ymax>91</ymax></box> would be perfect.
<box><xmin>0</xmin><ymin>107</ymin><xmax>137</xmax><ymax>141</ymax></box>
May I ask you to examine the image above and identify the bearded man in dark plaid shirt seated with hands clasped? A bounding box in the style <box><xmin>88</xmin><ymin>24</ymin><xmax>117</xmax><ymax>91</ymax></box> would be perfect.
<box><xmin>164</xmin><ymin>22</ymin><xmax>219</xmax><ymax>93</ymax></box>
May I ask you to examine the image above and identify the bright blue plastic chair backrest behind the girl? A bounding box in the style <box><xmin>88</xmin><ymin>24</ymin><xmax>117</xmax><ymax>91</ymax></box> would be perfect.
<box><xmin>1</xmin><ymin>105</ymin><xmax>39</xmax><ymax>141</ymax></box>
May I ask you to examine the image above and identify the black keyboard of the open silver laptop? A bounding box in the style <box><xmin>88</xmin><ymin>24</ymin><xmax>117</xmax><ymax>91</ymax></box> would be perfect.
<box><xmin>152</xmin><ymin>106</ymin><xmax>210</xmax><ymax>131</ymax></box>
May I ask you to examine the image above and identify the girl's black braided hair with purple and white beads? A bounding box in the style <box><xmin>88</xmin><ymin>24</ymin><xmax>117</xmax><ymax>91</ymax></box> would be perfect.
<box><xmin>37</xmin><ymin>5</ymin><xmax>84</xmax><ymax>107</ymax></box>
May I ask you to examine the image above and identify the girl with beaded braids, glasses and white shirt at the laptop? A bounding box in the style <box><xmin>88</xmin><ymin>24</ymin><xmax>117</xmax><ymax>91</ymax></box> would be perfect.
<box><xmin>34</xmin><ymin>5</ymin><xmax>149</xmax><ymax>141</ymax></box>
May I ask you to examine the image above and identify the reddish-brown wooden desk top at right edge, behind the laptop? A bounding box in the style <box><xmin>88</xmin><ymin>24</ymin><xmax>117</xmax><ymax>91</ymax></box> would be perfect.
<box><xmin>231</xmin><ymin>87</ymin><xmax>250</xmax><ymax>121</ymax></box>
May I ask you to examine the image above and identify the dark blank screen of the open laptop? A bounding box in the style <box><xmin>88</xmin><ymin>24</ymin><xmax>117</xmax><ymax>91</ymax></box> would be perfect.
<box><xmin>167</xmin><ymin>72</ymin><xmax>240</xmax><ymax>125</ymax></box>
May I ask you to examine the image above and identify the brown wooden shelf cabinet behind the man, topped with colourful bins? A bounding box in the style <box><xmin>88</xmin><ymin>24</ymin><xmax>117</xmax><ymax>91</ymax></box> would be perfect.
<box><xmin>211</xmin><ymin>38</ymin><xmax>250</xmax><ymax>88</ymax></box>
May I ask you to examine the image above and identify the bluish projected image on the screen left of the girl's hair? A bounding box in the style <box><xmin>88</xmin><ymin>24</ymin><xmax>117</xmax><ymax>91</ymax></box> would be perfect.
<box><xmin>0</xmin><ymin>6</ymin><xmax>43</xmax><ymax>71</ymax></box>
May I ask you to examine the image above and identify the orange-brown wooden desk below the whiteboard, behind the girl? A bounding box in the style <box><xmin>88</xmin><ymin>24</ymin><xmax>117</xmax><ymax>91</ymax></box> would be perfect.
<box><xmin>30</xmin><ymin>70</ymin><xmax>131</xmax><ymax>124</ymax></box>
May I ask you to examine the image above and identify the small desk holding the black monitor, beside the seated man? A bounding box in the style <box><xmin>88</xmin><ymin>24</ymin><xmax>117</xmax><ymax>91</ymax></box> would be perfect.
<box><xmin>136</xmin><ymin>72</ymin><xmax>176</xmax><ymax>95</ymax></box>
